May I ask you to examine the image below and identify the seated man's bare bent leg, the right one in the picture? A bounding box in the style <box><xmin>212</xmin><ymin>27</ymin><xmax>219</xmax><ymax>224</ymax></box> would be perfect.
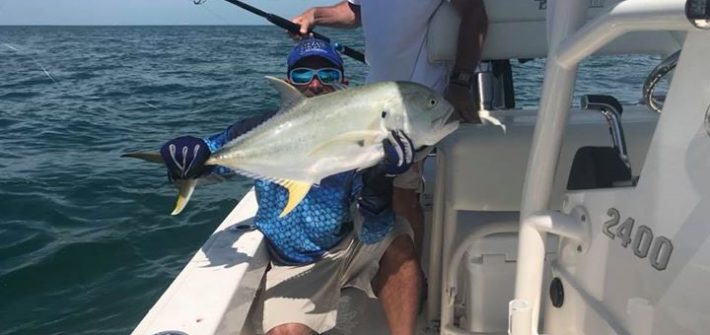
<box><xmin>375</xmin><ymin>235</ymin><xmax>421</xmax><ymax>335</ymax></box>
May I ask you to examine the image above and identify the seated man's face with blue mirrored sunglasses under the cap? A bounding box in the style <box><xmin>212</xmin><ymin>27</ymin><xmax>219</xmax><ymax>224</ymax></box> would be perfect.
<box><xmin>288</xmin><ymin>56</ymin><xmax>346</xmax><ymax>97</ymax></box>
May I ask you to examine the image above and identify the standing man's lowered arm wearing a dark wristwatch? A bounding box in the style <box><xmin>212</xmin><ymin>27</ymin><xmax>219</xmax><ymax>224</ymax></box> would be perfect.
<box><xmin>446</xmin><ymin>0</ymin><xmax>488</xmax><ymax>123</ymax></box>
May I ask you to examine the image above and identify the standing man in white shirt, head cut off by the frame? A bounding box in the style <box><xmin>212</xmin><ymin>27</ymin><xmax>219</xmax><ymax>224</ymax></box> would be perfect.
<box><xmin>292</xmin><ymin>0</ymin><xmax>488</xmax><ymax>260</ymax></box>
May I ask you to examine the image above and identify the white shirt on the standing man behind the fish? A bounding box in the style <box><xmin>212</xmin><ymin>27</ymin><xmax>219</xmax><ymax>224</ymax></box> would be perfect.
<box><xmin>348</xmin><ymin>0</ymin><xmax>448</xmax><ymax>93</ymax></box>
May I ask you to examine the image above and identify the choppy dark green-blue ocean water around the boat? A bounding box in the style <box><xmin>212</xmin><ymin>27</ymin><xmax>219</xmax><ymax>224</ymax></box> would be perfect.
<box><xmin>0</xmin><ymin>26</ymin><xmax>659</xmax><ymax>334</ymax></box>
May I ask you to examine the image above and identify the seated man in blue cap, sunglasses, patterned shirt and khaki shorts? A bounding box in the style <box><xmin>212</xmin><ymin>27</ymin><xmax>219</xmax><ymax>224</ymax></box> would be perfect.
<box><xmin>161</xmin><ymin>38</ymin><xmax>421</xmax><ymax>335</ymax></box>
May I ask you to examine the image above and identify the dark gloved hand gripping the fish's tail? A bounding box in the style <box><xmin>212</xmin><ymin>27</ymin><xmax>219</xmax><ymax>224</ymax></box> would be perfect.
<box><xmin>160</xmin><ymin>136</ymin><xmax>210</xmax><ymax>180</ymax></box>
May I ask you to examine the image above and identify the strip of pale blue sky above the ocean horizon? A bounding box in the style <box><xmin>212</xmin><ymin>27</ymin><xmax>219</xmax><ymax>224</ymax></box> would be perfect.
<box><xmin>0</xmin><ymin>0</ymin><xmax>338</xmax><ymax>25</ymax></box>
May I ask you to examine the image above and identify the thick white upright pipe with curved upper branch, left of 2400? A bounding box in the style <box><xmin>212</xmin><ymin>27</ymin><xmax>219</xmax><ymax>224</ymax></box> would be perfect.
<box><xmin>509</xmin><ymin>0</ymin><xmax>695</xmax><ymax>335</ymax></box>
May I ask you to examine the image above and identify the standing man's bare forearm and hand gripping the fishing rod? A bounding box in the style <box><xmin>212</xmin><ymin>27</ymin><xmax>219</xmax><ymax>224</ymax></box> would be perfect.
<box><xmin>291</xmin><ymin>0</ymin><xmax>360</xmax><ymax>35</ymax></box>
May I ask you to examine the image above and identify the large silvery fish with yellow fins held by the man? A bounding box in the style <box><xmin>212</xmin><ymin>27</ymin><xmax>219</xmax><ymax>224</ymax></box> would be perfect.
<box><xmin>128</xmin><ymin>77</ymin><xmax>458</xmax><ymax>216</ymax></box>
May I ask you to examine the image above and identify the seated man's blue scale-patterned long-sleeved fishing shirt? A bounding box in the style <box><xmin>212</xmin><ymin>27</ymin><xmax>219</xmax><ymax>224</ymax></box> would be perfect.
<box><xmin>204</xmin><ymin>113</ymin><xmax>394</xmax><ymax>265</ymax></box>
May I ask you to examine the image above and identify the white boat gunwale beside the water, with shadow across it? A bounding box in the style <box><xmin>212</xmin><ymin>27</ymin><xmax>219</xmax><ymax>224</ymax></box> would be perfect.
<box><xmin>133</xmin><ymin>190</ymin><xmax>268</xmax><ymax>335</ymax></box>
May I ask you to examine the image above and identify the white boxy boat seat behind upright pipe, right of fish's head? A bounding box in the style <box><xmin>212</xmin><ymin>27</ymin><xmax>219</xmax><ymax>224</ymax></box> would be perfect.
<box><xmin>434</xmin><ymin>106</ymin><xmax>658</xmax><ymax>211</ymax></box>
